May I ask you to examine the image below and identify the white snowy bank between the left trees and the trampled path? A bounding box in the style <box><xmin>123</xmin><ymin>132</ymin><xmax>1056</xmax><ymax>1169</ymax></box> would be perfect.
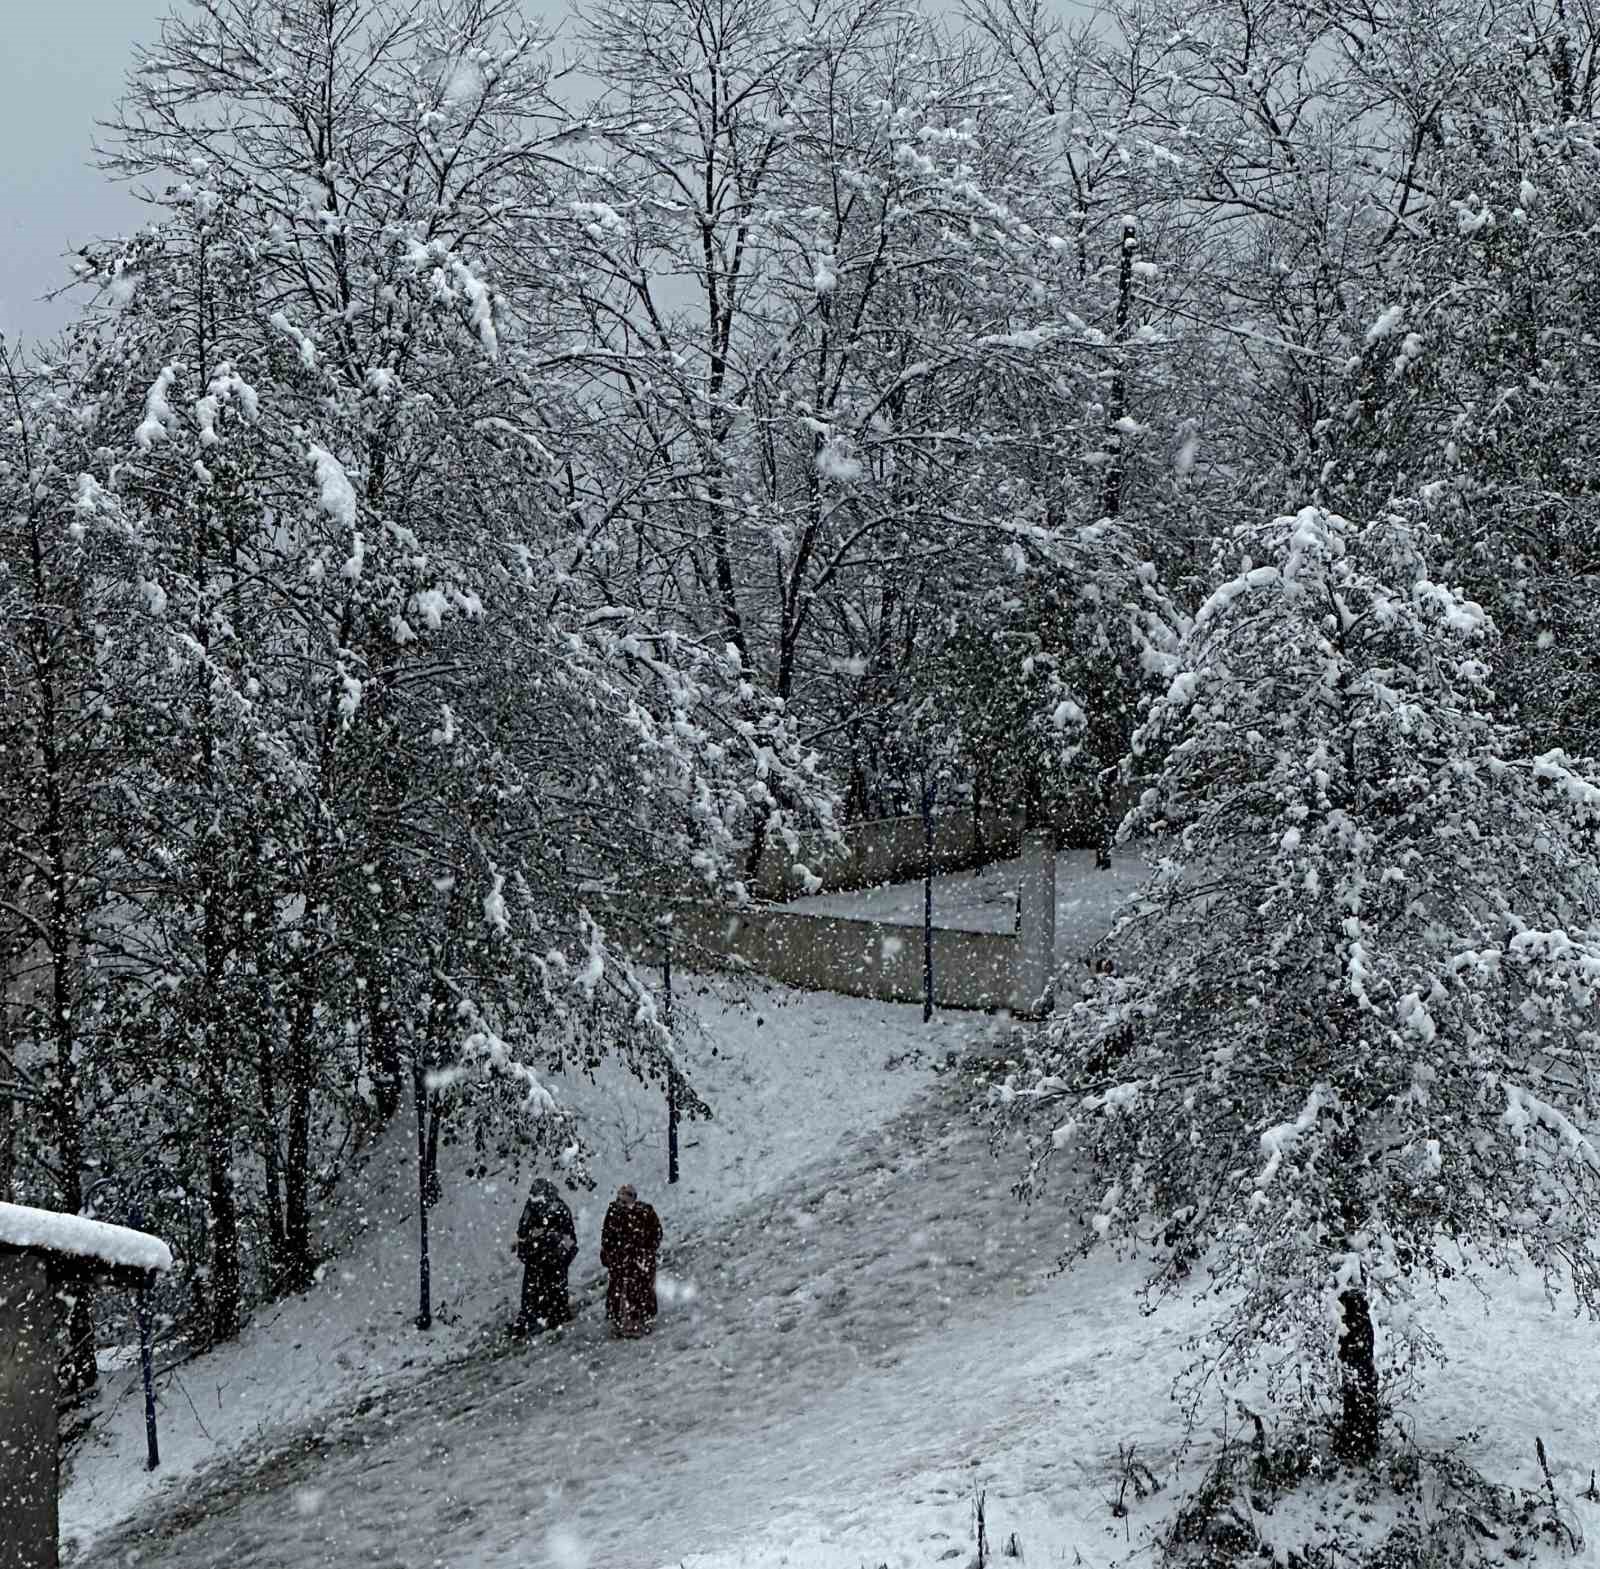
<box><xmin>61</xmin><ymin>977</ymin><xmax>987</xmax><ymax>1547</ymax></box>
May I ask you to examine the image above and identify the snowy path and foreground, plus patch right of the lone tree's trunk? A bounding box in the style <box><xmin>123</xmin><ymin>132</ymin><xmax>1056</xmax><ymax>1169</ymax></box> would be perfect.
<box><xmin>65</xmin><ymin>1080</ymin><xmax>1600</xmax><ymax>1569</ymax></box>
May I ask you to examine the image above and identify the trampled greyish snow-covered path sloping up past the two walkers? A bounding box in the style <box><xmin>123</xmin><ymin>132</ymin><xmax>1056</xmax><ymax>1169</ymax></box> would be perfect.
<box><xmin>85</xmin><ymin>1084</ymin><xmax>1203</xmax><ymax>1569</ymax></box>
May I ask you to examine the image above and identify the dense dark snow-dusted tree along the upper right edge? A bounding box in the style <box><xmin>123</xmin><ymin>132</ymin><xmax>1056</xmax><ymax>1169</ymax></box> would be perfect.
<box><xmin>1299</xmin><ymin>15</ymin><xmax>1600</xmax><ymax>764</ymax></box>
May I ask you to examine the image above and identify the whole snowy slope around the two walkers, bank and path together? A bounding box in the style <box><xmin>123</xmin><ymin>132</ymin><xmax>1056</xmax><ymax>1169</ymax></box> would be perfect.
<box><xmin>62</xmin><ymin>902</ymin><xmax>1600</xmax><ymax>1569</ymax></box>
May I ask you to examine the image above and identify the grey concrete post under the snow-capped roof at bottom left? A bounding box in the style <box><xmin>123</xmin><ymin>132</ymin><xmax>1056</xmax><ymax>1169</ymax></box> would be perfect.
<box><xmin>0</xmin><ymin>1249</ymin><xmax>59</xmax><ymax>1569</ymax></box>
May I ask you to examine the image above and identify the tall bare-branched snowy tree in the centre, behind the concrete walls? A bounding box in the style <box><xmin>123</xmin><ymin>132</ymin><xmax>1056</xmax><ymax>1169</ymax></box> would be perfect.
<box><xmin>566</xmin><ymin>0</ymin><xmax>1152</xmax><ymax>814</ymax></box>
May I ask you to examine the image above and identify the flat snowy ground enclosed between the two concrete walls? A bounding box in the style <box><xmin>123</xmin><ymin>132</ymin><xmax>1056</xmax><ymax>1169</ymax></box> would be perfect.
<box><xmin>789</xmin><ymin>849</ymin><xmax>1146</xmax><ymax>963</ymax></box>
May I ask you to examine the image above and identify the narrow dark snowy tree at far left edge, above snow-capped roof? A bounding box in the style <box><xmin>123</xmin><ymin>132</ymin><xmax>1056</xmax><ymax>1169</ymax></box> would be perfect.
<box><xmin>0</xmin><ymin>341</ymin><xmax>130</xmax><ymax>1387</ymax></box>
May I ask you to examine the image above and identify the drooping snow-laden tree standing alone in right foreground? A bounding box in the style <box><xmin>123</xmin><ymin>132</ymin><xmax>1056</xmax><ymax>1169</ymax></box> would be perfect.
<box><xmin>1000</xmin><ymin>509</ymin><xmax>1600</xmax><ymax>1459</ymax></box>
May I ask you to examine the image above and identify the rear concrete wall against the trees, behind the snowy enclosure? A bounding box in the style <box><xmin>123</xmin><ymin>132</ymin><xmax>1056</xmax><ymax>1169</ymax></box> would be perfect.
<box><xmin>750</xmin><ymin>811</ymin><xmax>1022</xmax><ymax>899</ymax></box>
